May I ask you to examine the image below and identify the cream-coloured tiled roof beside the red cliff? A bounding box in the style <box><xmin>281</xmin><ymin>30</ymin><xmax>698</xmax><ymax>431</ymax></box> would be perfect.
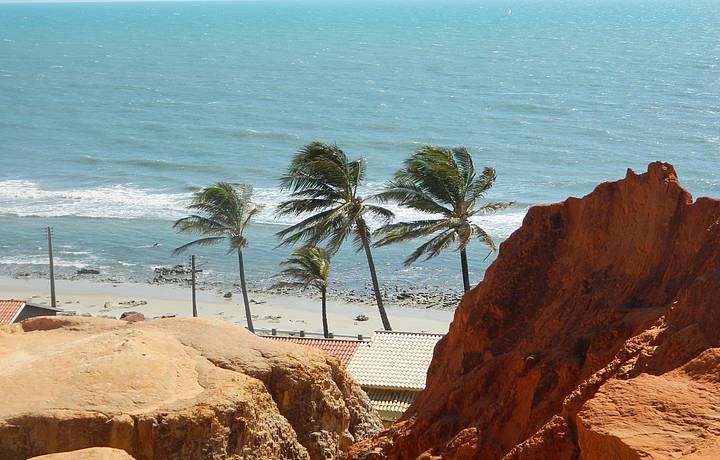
<box><xmin>348</xmin><ymin>331</ymin><xmax>443</xmax><ymax>391</ymax></box>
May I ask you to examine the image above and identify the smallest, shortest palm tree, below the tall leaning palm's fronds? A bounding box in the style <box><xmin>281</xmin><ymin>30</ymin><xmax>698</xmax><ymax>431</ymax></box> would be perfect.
<box><xmin>273</xmin><ymin>246</ymin><xmax>330</xmax><ymax>339</ymax></box>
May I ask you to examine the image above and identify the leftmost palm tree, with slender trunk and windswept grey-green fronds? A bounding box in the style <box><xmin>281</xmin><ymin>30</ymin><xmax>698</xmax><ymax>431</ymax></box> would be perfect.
<box><xmin>173</xmin><ymin>182</ymin><xmax>260</xmax><ymax>332</ymax></box>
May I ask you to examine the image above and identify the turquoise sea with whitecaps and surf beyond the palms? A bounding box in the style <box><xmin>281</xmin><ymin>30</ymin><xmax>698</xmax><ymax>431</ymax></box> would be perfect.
<box><xmin>0</xmin><ymin>0</ymin><xmax>720</xmax><ymax>294</ymax></box>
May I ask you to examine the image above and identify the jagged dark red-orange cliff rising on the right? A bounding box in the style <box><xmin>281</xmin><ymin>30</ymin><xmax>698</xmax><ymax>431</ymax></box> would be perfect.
<box><xmin>351</xmin><ymin>163</ymin><xmax>720</xmax><ymax>460</ymax></box>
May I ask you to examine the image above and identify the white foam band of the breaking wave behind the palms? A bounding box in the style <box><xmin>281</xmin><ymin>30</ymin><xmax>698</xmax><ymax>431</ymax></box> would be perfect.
<box><xmin>0</xmin><ymin>180</ymin><xmax>527</xmax><ymax>238</ymax></box>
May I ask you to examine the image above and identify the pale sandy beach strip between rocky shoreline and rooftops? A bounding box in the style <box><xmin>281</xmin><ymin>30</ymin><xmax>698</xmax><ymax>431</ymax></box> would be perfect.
<box><xmin>0</xmin><ymin>278</ymin><xmax>454</xmax><ymax>336</ymax></box>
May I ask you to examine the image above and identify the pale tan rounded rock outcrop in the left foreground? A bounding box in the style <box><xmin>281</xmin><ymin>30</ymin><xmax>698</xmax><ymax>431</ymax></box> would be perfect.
<box><xmin>0</xmin><ymin>317</ymin><xmax>380</xmax><ymax>460</ymax></box>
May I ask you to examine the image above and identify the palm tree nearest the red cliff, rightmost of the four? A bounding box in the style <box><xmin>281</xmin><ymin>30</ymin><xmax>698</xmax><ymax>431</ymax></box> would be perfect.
<box><xmin>375</xmin><ymin>146</ymin><xmax>512</xmax><ymax>291</ymax></box>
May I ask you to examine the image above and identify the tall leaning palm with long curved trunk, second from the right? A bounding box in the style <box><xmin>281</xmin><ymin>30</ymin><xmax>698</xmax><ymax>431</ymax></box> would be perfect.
<box><xmin>277</xmin><ymin>142</ymin><xmax>393</xmax><ymax>331</ymax></box>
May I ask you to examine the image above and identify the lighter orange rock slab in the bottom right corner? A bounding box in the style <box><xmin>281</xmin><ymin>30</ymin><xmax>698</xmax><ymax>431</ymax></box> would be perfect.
<box><xmin>576</xmin><ymin>348</ymin><xmax>720</xmax><ymax>460</ymax></box>
